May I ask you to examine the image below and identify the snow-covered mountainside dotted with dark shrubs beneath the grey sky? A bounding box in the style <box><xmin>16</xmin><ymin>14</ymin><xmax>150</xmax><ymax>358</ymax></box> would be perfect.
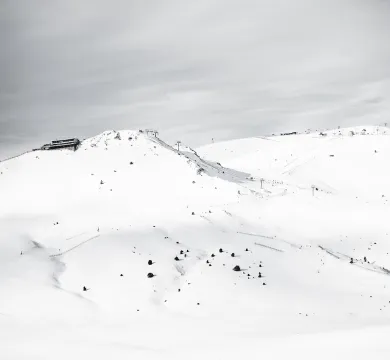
<box><xmin>0</xmin><ymin>126</ymin><xmax>390</xmax><ymax>360</ymax></box>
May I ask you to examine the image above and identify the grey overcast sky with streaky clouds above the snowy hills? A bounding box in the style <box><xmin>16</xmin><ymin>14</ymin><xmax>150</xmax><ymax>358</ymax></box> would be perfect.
<box><xmin>0</xmin><ymin>0</ymin><xmax>390</xmax><ymax>158</ymax></box>
